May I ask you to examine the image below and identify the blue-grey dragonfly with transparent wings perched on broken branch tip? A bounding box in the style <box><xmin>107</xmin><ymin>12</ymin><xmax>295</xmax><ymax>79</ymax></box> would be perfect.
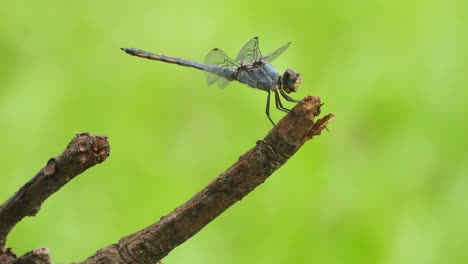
<box><xmin>121</xmin><ymin>37</ymin><xmax>302</xmax><ymax>126</ymax></box>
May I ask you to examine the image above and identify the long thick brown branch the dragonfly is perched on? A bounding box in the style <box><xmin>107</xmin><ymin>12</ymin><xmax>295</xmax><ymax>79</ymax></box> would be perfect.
<box><xmin>80</xmin><ymin>97</ymin><xmax>333</xmax><ymax>264</ymax></box>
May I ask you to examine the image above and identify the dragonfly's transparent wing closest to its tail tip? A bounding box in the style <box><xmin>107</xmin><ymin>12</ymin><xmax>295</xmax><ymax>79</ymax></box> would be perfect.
<box><xmin>205</xmin><ymin>48</ymin><xmax>240</xmax><ymax>88</ymax></box>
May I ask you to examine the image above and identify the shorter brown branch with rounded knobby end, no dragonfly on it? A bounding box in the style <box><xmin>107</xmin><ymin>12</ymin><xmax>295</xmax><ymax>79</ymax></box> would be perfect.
<box><xmin>0</xmin><ymin>133</ymin><xmax>109</xmax><ymax>255</ymax></box>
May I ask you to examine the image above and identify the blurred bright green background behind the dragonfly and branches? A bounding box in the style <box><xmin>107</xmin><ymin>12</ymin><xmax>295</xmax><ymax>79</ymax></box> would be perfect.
<box><xmin>0</xmin><ymin>0</ymin><xmax>468</xmax><ymax>264</ymax></box>
